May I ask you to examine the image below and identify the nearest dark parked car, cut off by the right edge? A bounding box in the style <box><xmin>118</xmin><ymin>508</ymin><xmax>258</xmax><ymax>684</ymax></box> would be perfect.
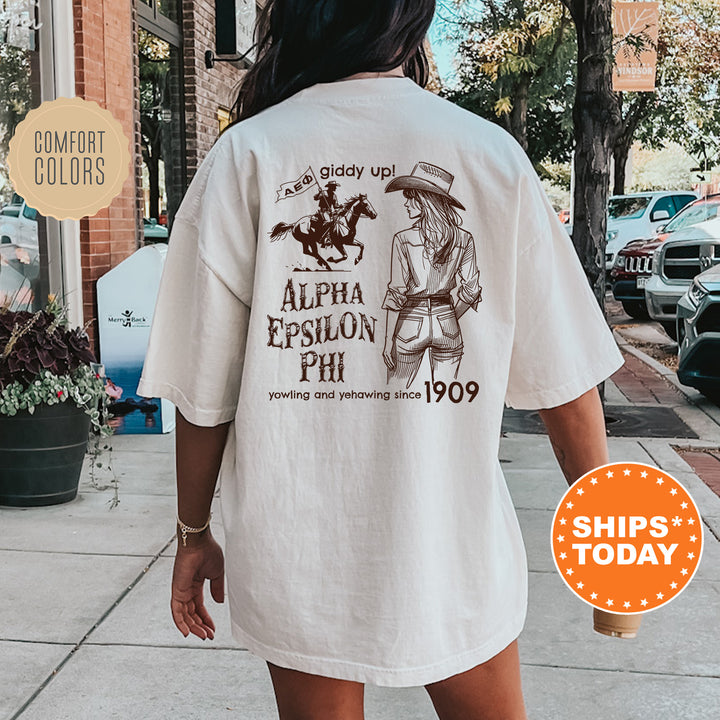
<box><xmin>677</xmin><ymin>264</ymin><xmax>720</xmax><ymax>400</ymax></box>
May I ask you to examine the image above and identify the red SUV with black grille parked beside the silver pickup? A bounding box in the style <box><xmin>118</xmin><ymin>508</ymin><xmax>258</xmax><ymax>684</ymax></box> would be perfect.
<box><xmin>610</xmin><ymin>195</ymin><xmax>720</xmax><ymax>319</ymax></box>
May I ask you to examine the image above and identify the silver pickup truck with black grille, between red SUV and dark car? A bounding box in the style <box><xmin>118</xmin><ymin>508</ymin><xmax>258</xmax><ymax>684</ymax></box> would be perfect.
<box><xmin>645</xmin><ymin>217</ymin><xmax>720</xmax><ymax>340</ymax></box>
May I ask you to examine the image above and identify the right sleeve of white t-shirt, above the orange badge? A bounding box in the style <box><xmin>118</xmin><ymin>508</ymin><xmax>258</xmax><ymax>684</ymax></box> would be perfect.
<box><xmin>505</xmin><ymin>163</ymin><xmax>623</xmax><ymax>410</ymax></box>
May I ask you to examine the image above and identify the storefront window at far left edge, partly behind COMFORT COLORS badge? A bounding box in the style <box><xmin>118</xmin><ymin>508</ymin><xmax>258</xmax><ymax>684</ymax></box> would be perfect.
<box><xmin>0</xmin><ymin>0</ymin><xmax>49</xmax><ymax>310</ymax></box>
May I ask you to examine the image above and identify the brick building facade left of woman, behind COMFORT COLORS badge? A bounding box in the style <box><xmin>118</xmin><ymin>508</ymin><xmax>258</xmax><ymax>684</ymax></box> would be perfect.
<box><xmin>72</xmin><ymin>0</ymin><xmax>249</xmax><ymax>348</ymax></box>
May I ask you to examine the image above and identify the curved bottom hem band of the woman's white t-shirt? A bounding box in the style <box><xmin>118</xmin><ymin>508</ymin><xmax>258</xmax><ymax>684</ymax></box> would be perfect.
<box><xmin>230</xmin><ymin>612</ymin><xmax>525</xmax><ymax>687</ymax></box>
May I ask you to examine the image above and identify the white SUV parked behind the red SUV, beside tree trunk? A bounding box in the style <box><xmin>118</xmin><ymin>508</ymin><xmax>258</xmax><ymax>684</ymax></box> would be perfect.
<box><xmin>605</xmin><ymin>190</ymin><xmax>698</xmax><ymax>271</ymax></box>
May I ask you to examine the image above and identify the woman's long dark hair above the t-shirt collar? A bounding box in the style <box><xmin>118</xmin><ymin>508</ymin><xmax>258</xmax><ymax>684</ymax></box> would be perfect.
<box><xmin>233</xmin><ymin>0</ymin><xmax>435</xmax><ymax>122</ymax></box>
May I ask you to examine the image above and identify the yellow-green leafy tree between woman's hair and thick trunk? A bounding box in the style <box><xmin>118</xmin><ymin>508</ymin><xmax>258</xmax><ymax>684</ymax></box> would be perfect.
<box><xmin>441</xmin><ymin>0</ymin><xmax>574</xmax><ymax>162</ymax></box>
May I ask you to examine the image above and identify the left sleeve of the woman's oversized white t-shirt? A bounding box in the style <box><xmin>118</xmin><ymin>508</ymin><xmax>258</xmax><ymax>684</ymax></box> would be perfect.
<box><xmin>138</xmin><ymin>133</ymin><xmax>257</xmax><ymax>427</ymax></box>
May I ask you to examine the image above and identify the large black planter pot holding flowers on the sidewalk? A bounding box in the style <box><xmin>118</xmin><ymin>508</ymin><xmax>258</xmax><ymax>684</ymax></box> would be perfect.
<box><xmin>0</xmin><ymin>402</ymin><xmax>90</xmax><ymax>507</ymax></box>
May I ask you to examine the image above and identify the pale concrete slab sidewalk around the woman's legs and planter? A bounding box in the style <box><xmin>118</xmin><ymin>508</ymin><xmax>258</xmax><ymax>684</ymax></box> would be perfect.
<box><xmin>0</xmin><ymin>366</ymin><xmax>720</xmax><ymax>720</ymax></box>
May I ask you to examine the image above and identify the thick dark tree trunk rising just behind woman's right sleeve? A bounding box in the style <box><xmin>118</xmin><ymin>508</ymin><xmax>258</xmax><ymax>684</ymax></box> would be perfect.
<box><xmin>566</xmin><ymin>0</ymin><xmax>618</xmax><ymax>309</ymax></box>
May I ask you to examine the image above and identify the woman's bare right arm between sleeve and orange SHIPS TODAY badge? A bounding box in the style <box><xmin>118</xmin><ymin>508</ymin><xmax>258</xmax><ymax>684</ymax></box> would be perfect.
<box><xmin>539</xmin><ymin>388</ymin><xmax>608</xmax><ymax>485</ymax></box>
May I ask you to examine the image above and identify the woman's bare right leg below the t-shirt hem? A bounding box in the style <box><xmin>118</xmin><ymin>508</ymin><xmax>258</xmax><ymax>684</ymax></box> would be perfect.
<box><xmin>425</xmin><ymin>641</ymin><xmax>527</xmax><ymax>720</ymax></box>
